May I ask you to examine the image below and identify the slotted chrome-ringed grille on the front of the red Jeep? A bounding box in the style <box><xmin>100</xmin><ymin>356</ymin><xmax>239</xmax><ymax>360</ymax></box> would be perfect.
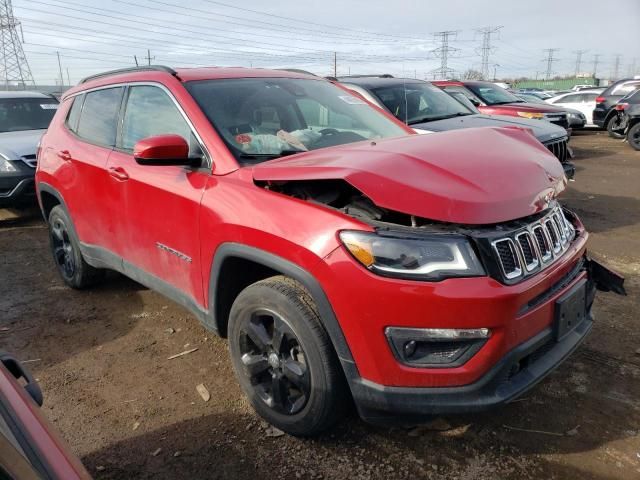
<box><xmin>491</xmin><ymin>206</ymin><xmax>575</xmax><ymax>280</ymax></box>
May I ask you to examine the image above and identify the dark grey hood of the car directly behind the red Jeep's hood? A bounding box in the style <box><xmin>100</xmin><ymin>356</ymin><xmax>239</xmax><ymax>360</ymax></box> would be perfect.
<box><xmin>418</xmin><ymin>113</ymin><xmax>567</xmax><ymax>143</ymax></box>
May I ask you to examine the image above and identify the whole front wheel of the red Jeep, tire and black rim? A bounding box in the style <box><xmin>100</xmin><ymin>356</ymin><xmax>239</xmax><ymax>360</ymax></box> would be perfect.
<box><xmin>229</xmin><ymin>276</ymin><xmax>351</xmax><ymax>436</ymax></box>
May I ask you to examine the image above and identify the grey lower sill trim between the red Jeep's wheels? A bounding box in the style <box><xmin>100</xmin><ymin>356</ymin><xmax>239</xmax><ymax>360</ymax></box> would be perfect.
<box><xmin>80</xmin><ymin>242</ymin><xmax>212</xmax><ymax>333</ymax></box>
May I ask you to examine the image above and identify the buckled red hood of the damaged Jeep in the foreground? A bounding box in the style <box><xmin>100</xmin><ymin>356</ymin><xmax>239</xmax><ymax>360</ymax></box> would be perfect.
<box><xmin>253</xmin><ymin>128</ymin><xmax>566</xmax><ymax>225</ymax></box>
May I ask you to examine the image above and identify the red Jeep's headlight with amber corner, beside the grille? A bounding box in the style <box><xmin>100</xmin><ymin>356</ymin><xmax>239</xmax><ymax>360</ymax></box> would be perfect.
<box><xmin>340</xmin><ymin>231</ymin><xmax>484</xmax><ymax>281</ymax></box>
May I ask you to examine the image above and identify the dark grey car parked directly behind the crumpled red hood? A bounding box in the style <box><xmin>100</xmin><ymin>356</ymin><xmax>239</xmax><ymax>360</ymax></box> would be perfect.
<box><xmin>337</xmin><ymin>76</ymin><xmax>575</xmax><ymax>179</ymax></box>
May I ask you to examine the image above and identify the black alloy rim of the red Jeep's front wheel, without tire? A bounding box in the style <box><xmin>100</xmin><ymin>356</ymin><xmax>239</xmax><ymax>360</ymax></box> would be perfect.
<box><xmin>239</xmin><ymin>309</ymin><xmax>311</xmax><ymax>415</ymax></box>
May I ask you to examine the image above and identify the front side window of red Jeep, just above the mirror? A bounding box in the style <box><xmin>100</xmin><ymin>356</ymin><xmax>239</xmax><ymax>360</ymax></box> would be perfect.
<box><xmin>120</xmin><ymin>85</ymin><xmax>194</xmax><ymax>150</ymax></box>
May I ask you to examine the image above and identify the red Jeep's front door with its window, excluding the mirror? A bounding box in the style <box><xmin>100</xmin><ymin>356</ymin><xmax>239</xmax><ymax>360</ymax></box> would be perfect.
<box><xmin>107</xmin><ymin>84</ymin><xmax>211</xmax><ymax>305</ymax></box>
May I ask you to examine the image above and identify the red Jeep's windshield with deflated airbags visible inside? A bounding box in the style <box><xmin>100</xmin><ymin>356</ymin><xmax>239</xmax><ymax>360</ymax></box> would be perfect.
<box><xmin>186</xmin><ymin>78</ymin><xmax>407</xmax><ymax>164</ymax></box>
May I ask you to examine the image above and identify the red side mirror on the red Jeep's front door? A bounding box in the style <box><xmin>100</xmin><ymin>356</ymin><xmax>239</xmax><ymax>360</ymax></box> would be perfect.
<box><xmin>133</xmin><ymin>134</ymin><xmax>199</xmax><ymax>166</ymax></box>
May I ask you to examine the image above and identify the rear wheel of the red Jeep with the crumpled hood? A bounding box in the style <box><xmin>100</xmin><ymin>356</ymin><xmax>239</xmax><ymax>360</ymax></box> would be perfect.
<box><xmin>49</xmin><ymin>205</ymin><xmax>104</xmax><ymax>289</ymax></box>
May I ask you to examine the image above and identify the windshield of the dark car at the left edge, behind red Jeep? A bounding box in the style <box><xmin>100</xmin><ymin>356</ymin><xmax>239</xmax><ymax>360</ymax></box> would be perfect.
<box><xmin>0</xmin><ymin>97</ymin><xmax>58</xmax><ymax>132</ymax></box>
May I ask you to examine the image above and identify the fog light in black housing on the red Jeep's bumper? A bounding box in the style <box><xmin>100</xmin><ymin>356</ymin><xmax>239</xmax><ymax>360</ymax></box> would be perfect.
<box><xmin>385</xmin><ymin>327</ymin><xmax>491</xmax><ymax>368</ymax></box>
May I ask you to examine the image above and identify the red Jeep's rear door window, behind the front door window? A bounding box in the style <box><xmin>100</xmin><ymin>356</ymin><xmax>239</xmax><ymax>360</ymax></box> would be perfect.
<box><xmin>74</xmin><ymin>87</ymin><xmax>123</xmax><ymax>147</ymax></box>
